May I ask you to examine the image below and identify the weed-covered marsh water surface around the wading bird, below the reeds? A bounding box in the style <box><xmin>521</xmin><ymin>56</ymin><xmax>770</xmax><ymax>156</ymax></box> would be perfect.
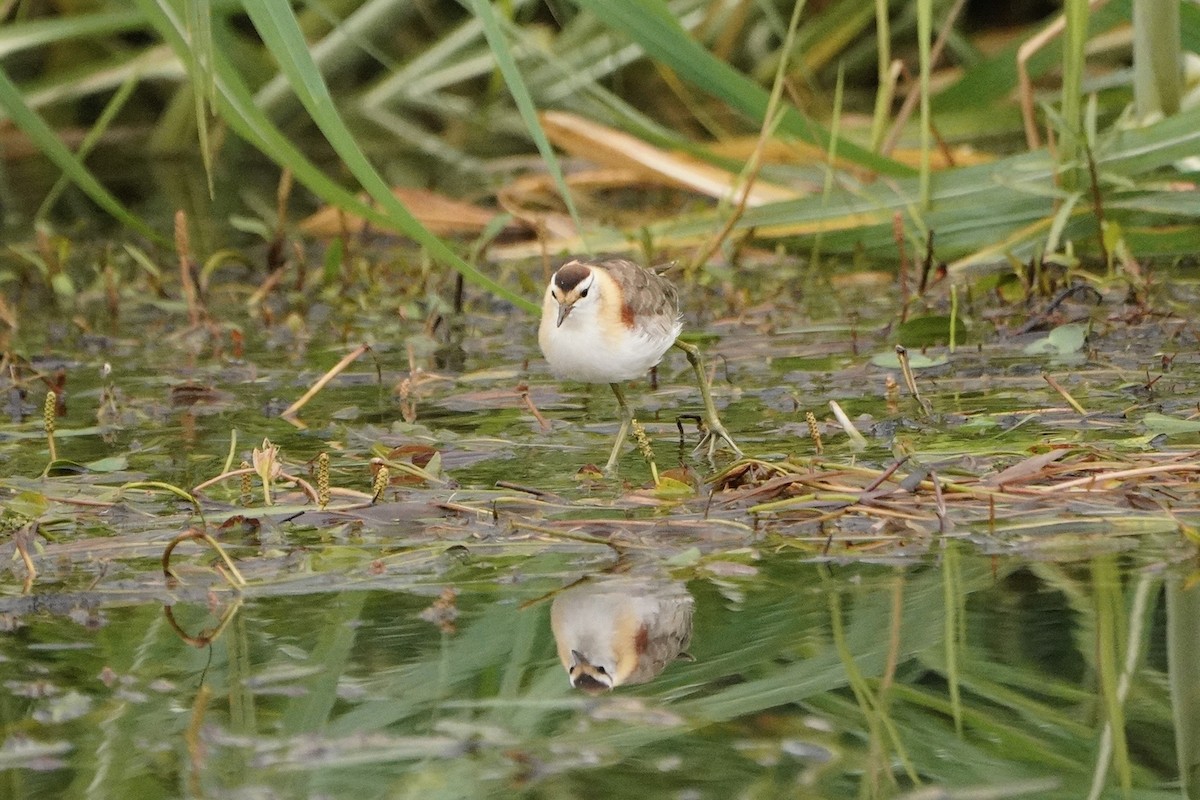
<box><xmin>0</xmin><ymin>159</ymin><xmax>1200</xmax><ymax>799</ymax></box>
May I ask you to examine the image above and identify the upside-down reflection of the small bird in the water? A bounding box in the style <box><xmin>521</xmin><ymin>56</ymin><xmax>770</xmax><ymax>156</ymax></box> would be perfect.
<box><xmin>550</xmin><ymin>575</ymin><xmax>695</xmax><ymax>694</ymax></box>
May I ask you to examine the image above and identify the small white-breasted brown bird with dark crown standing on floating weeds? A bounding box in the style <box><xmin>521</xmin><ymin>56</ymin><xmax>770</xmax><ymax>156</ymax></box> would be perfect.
<box><xmin>538</xmin><ymin>258</ymin><xmax>742</xmax><ymax>473</ymax></box>
